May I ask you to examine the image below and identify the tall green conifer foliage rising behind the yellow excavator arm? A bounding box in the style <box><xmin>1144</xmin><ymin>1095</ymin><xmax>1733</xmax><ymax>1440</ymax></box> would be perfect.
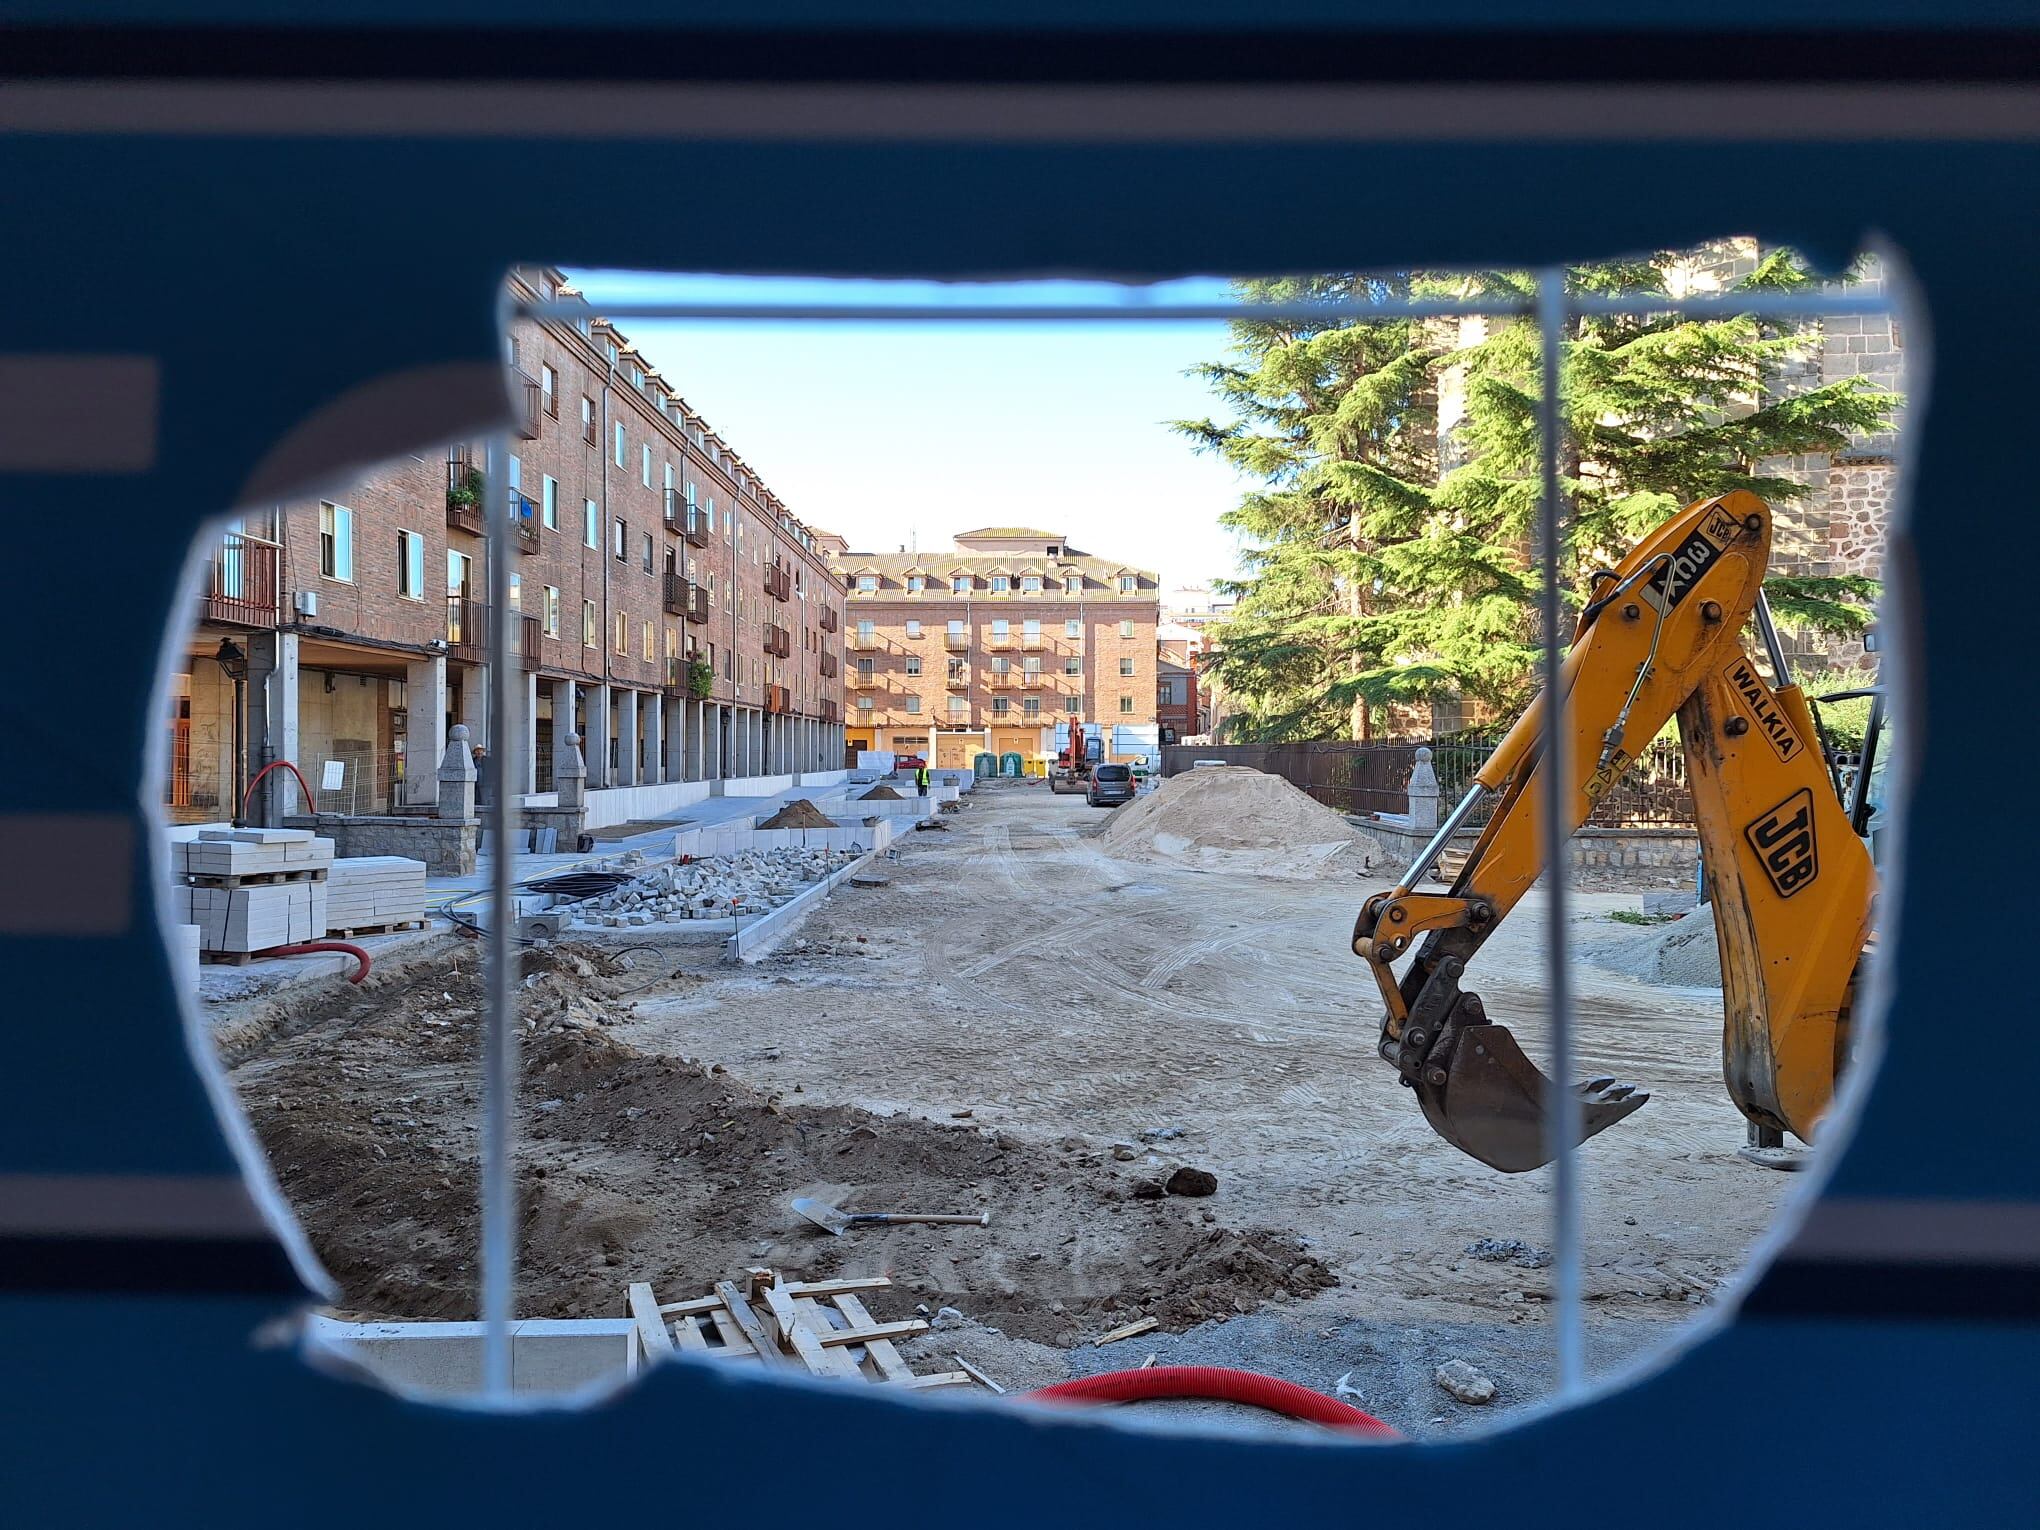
<box><xmin>1177</xmin><ymin>253</ymin><xmax>1895</xmax><ymax>738</ymax></box>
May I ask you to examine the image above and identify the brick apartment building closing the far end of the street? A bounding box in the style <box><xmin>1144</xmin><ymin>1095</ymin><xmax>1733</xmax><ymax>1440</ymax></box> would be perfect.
<box><xmin>830</xmin><ymin>526</ymin><xmax>1159</xmax><ymax>769</ymax></box>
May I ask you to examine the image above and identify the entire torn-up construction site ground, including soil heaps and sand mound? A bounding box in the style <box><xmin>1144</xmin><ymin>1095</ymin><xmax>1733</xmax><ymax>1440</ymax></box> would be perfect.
<box><xmin>200</xmin><ymin>769</ymin><xmax>1787</xmax><ymax>1434</ymax></box>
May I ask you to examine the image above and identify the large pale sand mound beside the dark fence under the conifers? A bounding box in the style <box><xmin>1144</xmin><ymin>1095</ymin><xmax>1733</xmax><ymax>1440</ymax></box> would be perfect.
<box><xmin>1102</xmin><ymin>765</ymin><xmax>1373</xmax><ymax>877</ymax></box>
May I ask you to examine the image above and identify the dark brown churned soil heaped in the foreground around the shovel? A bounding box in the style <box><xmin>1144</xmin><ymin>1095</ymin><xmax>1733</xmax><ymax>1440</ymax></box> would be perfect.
<box><xmin>233</xmin><ymin>947</ymin><xmax>1336</xmax><ymax>1344</ymax></box>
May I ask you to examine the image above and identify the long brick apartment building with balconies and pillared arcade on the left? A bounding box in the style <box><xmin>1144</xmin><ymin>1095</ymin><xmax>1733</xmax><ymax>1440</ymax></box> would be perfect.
<box><xmin>169</xmin><ymin>269</ymin><xmax>845</xmax><ymax>820</ymax></box>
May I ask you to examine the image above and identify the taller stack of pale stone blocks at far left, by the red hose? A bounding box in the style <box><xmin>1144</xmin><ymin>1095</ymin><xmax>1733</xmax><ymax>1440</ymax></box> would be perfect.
<box><xmin>169</xmin><ymin>828</ymin><xmax>333</xmax><ymax>951</ymax></box>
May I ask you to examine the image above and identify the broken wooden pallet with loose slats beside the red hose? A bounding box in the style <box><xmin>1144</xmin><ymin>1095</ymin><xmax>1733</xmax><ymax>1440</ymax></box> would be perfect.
<box><xmin>624</xmin><ymin>1269</ymin><xmax>977</xmax><ymax>1389</ymax></box>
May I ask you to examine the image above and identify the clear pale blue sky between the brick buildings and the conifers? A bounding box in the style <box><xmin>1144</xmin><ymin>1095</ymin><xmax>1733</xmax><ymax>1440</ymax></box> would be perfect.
<box><xmin>569</xmin><ymin>271</ymin><xmax>1246</xmax><ymax>590</ymax></box>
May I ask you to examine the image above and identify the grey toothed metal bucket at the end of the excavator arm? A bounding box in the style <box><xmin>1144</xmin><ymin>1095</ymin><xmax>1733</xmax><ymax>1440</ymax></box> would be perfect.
<box><xmin>1416</xmin><ymin>1026</ymin><xmax>1650</xmax><ymax>1175</ymax></box>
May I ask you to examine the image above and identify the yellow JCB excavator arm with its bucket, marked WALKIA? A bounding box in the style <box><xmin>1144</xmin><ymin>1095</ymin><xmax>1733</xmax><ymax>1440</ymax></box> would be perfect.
<box><xmin>1353</xmin><ymin>492</ymin><xmax>1881</xmax><ymax>1173</ymax></box>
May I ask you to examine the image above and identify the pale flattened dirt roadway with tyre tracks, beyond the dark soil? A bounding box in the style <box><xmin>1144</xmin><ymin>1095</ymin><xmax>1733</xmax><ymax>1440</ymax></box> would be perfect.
<box><xmin>620</xmin><ymin>787</ymin><xmax>1785</xmax><ymax>1322</ymax></box>
